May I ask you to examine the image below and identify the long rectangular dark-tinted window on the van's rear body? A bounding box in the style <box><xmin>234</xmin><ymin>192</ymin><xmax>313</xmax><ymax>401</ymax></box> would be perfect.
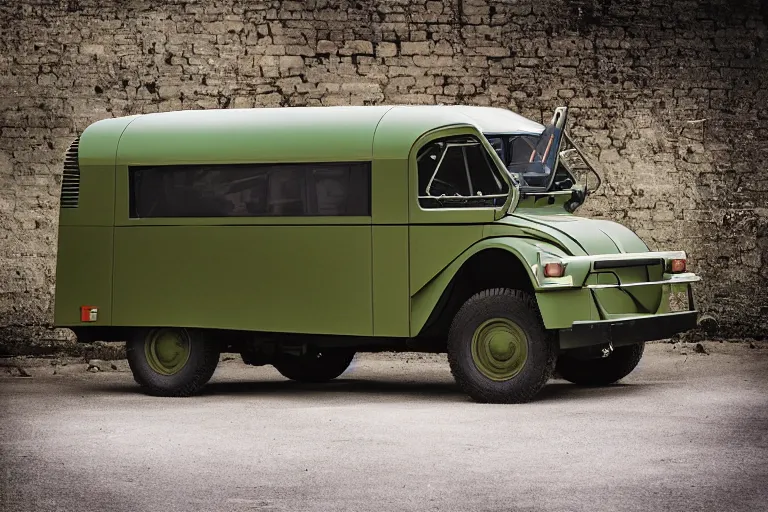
<box><xmin>129</xmin><ymin>162</ymin><xmax>371</xmax><ymax>218</ymax></box>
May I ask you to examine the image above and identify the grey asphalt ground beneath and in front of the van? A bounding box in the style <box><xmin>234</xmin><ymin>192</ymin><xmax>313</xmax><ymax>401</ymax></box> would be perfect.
<box><xmin>0</xmin><ymin>342</ymin><xmax>768</xmax><ymax>512</ymax></box>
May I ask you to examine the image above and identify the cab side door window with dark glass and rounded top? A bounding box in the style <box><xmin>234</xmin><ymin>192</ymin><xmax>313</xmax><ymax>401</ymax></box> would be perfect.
<box><xmin>416</xmin><ymin>136</ymin><xmax>509</xmax><ymax>208</ymax></box>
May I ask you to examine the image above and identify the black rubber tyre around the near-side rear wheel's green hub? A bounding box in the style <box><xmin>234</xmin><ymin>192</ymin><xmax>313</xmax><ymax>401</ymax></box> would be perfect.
<box><xmin>125</xmin><ymin>328</ymin><xmax>220</xmax><ymax>397</ymax></box>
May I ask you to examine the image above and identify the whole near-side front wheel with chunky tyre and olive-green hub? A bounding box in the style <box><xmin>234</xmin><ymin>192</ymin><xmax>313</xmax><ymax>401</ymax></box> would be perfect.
<box><xmin>448</xmin><ymin>288</ymin><xmax>556</xmax><ymax>403</ymax></box>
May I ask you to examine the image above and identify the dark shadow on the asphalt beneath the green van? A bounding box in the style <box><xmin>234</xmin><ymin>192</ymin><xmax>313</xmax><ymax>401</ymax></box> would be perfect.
<box><xmin>92</xmin><ymin>378</ymin><xmax>664</xmax><ymax>403</ymax></box>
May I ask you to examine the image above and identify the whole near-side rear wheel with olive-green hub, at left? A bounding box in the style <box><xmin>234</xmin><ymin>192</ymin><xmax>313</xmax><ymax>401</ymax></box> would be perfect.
<box><xmin>126</xmin><ymin>328</ymin><xmax>219</xmax><ymax>397</ymax></box>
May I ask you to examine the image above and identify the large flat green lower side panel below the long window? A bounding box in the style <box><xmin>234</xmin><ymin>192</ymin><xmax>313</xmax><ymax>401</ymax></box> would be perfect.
<box><xmin>113</xmin><ymin>226</ymin><xmax>373</xmax><ymax>335</ymax></box>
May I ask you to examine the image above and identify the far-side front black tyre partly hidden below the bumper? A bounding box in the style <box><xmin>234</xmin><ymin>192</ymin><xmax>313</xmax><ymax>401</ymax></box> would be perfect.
<box><xmin>555</xmin><ymin>343</ymin><xmax>645</xmax><ymax>386</ymax></box>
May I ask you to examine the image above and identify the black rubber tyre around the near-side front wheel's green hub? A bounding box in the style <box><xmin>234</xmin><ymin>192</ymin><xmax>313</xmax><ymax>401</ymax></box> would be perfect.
<box><xmin>448</xmin><ymin>288</ymin><xmax>556</xmax><ymax>403</ymax></box>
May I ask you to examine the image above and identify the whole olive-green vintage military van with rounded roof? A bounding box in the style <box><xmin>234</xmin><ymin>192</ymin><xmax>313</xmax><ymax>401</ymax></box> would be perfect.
<box><xmin>55</xmin><ymin>106</ymin><xmax>699</xmax><ymax>403</ymax></box>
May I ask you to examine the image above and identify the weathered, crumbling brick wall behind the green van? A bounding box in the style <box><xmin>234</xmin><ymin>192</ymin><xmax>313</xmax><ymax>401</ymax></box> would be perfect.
<box><xmin>0</xmin><ymin>0</ymin><xmax>768</xmax><ymax>350</ymax></box>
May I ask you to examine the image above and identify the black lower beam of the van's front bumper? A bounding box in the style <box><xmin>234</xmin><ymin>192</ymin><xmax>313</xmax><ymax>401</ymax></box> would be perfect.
<box><xmin>558</xmin><ymin>311</ymin><xmax>698</xmax><ymax>350</ymax></box>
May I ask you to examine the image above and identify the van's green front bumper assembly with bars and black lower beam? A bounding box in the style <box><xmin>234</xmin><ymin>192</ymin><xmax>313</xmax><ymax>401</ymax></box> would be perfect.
<box><xmin>532</xmin><ymin>251</ymin><xmax>701</xmax><ymax>350</ymax></box>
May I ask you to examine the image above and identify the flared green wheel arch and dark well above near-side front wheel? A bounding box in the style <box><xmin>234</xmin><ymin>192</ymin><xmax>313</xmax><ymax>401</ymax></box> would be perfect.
<box><xmin>410</xmin><ymin>237</ymin><xmax>554</xmax><ymax>340</ymax></box>
